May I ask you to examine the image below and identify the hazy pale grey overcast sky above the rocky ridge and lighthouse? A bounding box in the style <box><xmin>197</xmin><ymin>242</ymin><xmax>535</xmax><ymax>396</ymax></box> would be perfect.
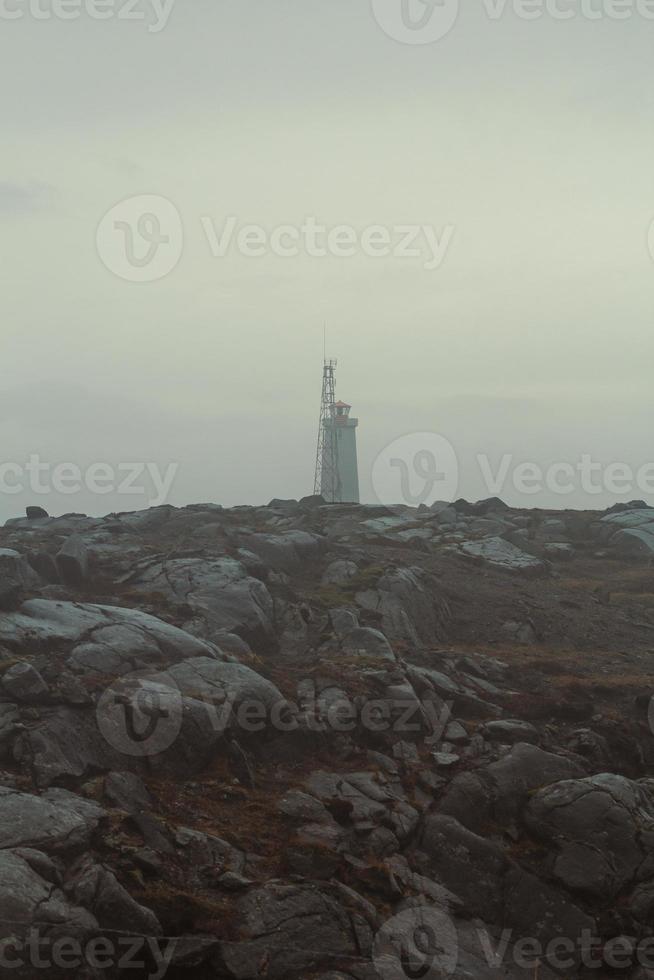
<box><xmin>0</xmin><ymin>0</ymin><xmax>654</xmax><ymax>519</ymax></box>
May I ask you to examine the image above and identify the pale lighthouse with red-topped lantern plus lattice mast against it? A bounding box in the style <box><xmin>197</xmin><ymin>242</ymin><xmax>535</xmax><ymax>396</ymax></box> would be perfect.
<box><xmin>314</xmin><ymin>360</ymin><xmax>359</xmax><ymax>504</ymax></box>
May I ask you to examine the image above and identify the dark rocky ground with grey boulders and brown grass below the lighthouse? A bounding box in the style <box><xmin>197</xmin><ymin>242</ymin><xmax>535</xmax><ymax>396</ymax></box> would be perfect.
<box><xmin>0</xmin><ymin>498</ymin><xmax>654</xmax><ymax>980</ymax></box>
